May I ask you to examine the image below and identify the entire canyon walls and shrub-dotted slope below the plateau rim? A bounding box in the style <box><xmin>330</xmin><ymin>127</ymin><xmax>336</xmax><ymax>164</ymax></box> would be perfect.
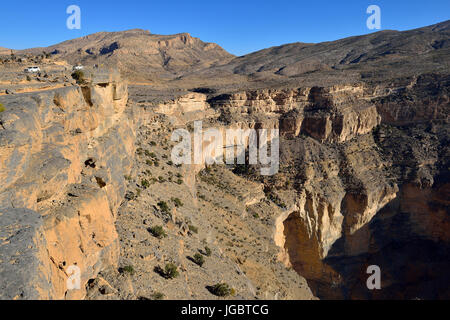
<box><xmin>0</xmin><ymin>69</ymin><xmax>449</xmax><ymax>299</ymax></box>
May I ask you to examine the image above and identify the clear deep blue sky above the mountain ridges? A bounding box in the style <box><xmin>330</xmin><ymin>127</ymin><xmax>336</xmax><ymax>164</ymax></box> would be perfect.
<box><xmin>0</xmin><ymin>0</ymin><xmax>450</xmax><ymax>55</ymax></box>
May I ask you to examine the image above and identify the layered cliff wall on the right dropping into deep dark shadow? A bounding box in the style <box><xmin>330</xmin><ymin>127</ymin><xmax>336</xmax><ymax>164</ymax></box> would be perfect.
<box><xmin>205</xmin><ymin>74</ymin><xmax>449</xmax><ymax>298</ymax></box>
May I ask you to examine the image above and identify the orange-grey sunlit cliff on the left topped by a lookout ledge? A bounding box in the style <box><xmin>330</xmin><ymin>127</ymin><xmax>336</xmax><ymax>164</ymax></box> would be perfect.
<box><xmin>0</xmin><ymin>74</ymin><xmax>134</xmax><ymax>299</ymax></box>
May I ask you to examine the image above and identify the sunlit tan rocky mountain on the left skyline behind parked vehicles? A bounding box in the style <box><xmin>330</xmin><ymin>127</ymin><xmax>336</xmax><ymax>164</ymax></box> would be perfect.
<box><xmin>20</xmin><ymin>29</ymin><xmax>233</xmax><ymax>81</ymax></box>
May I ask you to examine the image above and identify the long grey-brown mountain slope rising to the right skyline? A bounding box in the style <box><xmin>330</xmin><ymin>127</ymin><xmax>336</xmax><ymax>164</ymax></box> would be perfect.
<box><xmin>175</xmin><ymin>21</ymin><xmax>450</xmax><ymax>91</ymax></box>
